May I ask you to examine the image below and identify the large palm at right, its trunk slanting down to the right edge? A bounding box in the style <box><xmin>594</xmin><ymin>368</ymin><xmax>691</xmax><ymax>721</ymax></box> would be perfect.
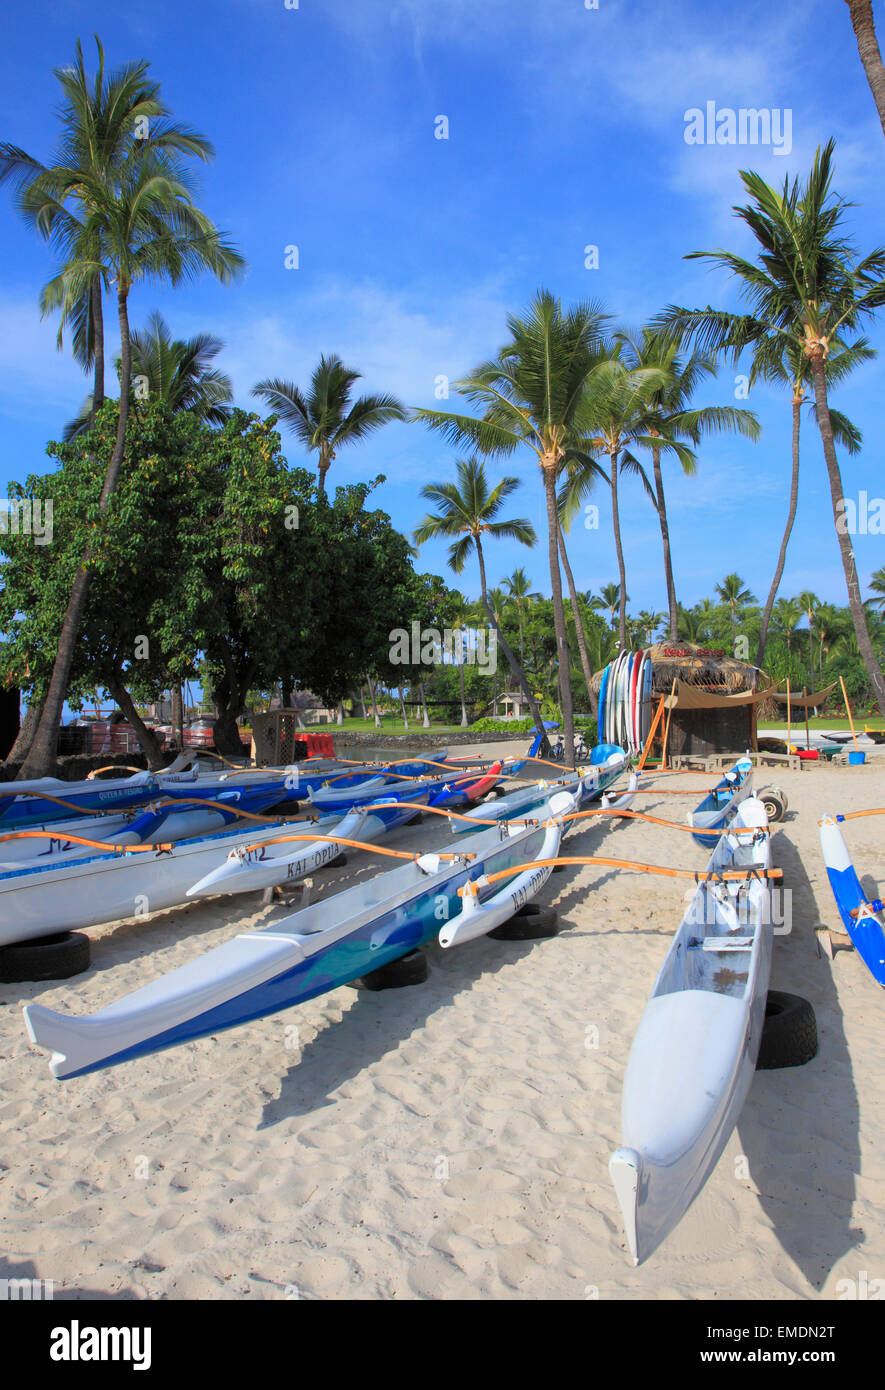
<box><xmin>661</xmin><ymin>140</ymin><xmax>885</xmax><ymax>716</ymax></box>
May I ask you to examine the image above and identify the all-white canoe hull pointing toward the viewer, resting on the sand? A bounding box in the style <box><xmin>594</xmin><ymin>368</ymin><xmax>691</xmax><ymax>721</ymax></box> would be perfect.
<box><xmin>609</xmin><ymin>796</ymin><xmax>772</xmax><ymax>1264</ymax></box>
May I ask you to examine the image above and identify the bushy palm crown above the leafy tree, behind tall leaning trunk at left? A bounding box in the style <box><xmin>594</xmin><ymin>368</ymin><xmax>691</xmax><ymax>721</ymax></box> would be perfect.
<box><xmin>64</xmin><ymin>311</ymin><xmax>233</xmax><ymax>439</ymax></box>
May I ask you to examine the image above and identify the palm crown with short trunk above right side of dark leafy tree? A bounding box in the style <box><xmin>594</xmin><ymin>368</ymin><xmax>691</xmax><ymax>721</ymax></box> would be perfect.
<box><xmin>251</xmin><ymin>354</ymin><xmax>406</xmax><ymax>496</ymax></box>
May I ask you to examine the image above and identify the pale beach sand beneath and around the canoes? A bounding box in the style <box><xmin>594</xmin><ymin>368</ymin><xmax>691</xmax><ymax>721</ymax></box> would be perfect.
<box><xmin>0</xmin><ymin>745</ymin><xmax>885</xmax><ymax>1300</ymax></box>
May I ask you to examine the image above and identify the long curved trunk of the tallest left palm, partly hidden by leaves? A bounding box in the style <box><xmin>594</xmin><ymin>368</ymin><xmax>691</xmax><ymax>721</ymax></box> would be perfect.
<box><xmin>18</xmin><ymin>285</ymin><xmax>132</xmax><ymax>780</ymax></box>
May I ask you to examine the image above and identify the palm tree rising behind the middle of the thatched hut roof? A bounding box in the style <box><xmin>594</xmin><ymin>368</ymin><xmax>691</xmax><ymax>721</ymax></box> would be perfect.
<box><xmin>617</xmin><ymin>327</ymin><xmax>760</xmax><ymax>641</ymax></box>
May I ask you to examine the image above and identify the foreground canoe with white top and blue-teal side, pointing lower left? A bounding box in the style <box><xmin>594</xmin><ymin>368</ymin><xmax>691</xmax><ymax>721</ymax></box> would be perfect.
<box><xmin>25</xmin><ymin>794</ymin><xmax>575</xmax><ymax>1079</ymax></box>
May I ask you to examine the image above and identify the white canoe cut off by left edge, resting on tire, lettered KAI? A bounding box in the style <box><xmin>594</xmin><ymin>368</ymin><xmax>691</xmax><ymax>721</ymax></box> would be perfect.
<box><xmin>0</xmin><ymin>795</ymin><xmax>421</xmax><ymax>945</ymax></box>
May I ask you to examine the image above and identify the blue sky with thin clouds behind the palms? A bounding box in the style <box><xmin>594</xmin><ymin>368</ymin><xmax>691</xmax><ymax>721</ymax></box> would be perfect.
<box><xmin>0</xmin><ymin>0</ymin><xmax>885</xmax><ymax>612</ymax></box>
